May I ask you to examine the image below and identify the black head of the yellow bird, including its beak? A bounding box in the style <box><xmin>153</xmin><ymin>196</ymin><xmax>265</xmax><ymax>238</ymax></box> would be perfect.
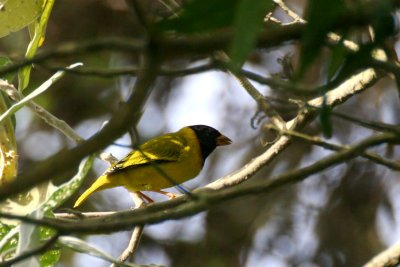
<box><xmin>189</xmin><ymin>125</ymin><xmax>232</xmax><ymax>163</ymax></box>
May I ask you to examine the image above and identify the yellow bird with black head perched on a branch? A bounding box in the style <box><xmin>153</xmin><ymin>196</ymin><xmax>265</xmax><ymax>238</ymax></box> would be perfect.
<box><xmin>74</xmin><ymin>125</ymin><xmax>232</xmax><ymax>208</ymax></box>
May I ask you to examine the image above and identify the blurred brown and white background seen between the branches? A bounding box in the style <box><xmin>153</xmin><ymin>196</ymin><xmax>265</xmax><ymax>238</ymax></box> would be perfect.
<box><xmin>0</xmin><ymin>0</ymin><xmax>400</xmax><ymax>267</ymax></box>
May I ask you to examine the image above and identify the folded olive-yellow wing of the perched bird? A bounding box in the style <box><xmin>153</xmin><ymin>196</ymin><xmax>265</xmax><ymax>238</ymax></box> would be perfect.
<box><xmin>105</xmin><ymin>134</ymin><xmax>186</xmax><ymax>174</ymax></box>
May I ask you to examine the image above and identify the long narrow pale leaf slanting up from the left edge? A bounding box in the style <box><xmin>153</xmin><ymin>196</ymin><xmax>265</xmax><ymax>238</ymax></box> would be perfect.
<box><xmin>0</xmin><ymin>63</ymin><xmax>82</xmax><ymax>124</ymax></box>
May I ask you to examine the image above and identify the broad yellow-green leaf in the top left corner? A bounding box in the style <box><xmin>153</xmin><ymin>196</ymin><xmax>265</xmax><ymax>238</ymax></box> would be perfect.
<box><xmin>0</xmin><ymin>0</ymin><xmax>44</xmax><ymax>37</ymax></box>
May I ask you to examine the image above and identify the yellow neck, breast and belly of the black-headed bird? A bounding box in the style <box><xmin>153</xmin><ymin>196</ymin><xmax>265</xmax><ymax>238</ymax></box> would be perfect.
<box><xmin>107</xmin><ymin>128</ymin><xmax>203</xmax><ymax>192</ymax></box>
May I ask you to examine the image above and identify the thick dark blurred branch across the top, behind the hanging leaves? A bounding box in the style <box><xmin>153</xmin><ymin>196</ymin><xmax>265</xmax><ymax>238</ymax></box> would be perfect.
<box><xmin>0</xmin><ymin>25</ymin><xmax>303</xmax><ymax>76</ymax></box>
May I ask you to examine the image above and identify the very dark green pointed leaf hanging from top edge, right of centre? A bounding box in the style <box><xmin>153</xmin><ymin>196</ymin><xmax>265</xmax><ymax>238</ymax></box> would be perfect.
<box><xmin>296</xmin><ymin>0</ymin><xmax>346</xmax><ymax>79</ymax></box>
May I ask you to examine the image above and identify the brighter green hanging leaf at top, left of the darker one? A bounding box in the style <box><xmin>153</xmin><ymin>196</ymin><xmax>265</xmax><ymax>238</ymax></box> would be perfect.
<box><xmin>228</xmin><ymin>0</ymin><xmax>274</xmax><ymax>69</ymax></box>
